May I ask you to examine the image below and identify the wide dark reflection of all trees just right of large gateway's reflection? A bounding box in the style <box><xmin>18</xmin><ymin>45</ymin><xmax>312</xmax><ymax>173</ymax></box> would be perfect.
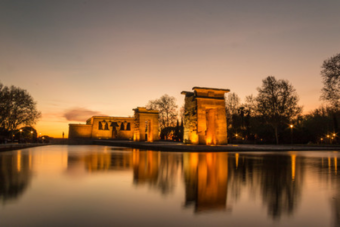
<box><xmin>228</xmin><ymin>153</ymin><xmax>303</xmax><ymax>218</ymax></box>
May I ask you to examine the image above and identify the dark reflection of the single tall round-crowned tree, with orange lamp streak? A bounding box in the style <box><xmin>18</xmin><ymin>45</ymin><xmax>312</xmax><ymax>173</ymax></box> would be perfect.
<box><xmin>260</xmin><ymin>155</ymin><xmax>303</xmax><ymax>218</ymax></box>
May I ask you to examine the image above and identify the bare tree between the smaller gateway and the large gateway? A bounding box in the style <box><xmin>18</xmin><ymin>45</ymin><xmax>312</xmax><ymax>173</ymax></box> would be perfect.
<box><xmin>146</xmin><ymin>94</ymin><xmax>178</xmax><ymax>129</ymax></box>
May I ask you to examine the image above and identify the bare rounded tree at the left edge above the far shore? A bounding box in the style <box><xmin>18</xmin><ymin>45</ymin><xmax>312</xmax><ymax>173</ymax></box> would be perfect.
<box><xmin>0</xmin><ymin>83</ymin><xmax>41</xmax><ymax>131</ymax></box>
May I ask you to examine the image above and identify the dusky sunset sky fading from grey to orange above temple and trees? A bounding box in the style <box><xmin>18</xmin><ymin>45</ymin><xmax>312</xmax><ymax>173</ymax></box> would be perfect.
<box><xmin>0</xmin><ymin>0</ymin><xmax>340</xmax><ymax>137</ymax></box>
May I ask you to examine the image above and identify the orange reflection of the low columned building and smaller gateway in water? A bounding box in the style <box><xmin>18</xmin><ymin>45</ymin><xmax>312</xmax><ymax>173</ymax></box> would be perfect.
<box><xmin>68</xmin><ymin>149</ymin><xmax>182</xmax><ymax>194</ymax></box>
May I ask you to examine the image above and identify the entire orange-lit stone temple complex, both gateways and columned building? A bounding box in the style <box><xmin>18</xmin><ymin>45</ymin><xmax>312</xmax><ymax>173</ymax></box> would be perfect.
<box><xmin>69</xmin><ymin>87</ymin><xmax>229</xmax><ymax>145</ymax></box>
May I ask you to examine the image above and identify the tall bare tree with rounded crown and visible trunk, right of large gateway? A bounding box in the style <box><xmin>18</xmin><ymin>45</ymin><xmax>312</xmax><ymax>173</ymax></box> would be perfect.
<box><xmin>256</xmin><ymin>76</ymin><xmax>302</xmax><ymax>144</ymax></box>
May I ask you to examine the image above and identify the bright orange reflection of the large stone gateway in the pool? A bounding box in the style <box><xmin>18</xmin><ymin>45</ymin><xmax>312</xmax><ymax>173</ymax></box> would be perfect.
<box><xmin>183</xmin><ymin>153</ymin><xmax>228</xmax><ymax>212</ymax></box>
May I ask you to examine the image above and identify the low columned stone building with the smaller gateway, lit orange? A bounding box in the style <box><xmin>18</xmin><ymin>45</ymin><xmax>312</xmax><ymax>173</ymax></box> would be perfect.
<box><xmin>69</xmin><ymin>107</ymin><xmax>159</xmax><ymax>142</ymax></box>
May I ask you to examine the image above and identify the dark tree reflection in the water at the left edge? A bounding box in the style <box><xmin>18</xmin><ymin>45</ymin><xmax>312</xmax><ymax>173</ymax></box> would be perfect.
<box><xmin>0</xmin><ymin>150</ymin><xmax>32</xmax><ymax>202</ymax></box>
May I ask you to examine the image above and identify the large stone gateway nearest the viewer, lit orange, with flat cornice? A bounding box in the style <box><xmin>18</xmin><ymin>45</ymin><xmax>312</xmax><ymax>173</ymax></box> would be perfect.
<box><xmin>181</xmin><ymin>87</ymin><xmax>229</xmax><ymax>145</ymax></box>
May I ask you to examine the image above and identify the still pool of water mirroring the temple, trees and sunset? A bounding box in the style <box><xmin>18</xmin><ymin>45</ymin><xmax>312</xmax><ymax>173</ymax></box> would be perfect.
<box><xmin>0</xmin><ymin>146</ymin><xmax>340</xmax><ymax>227</ymax></box>
